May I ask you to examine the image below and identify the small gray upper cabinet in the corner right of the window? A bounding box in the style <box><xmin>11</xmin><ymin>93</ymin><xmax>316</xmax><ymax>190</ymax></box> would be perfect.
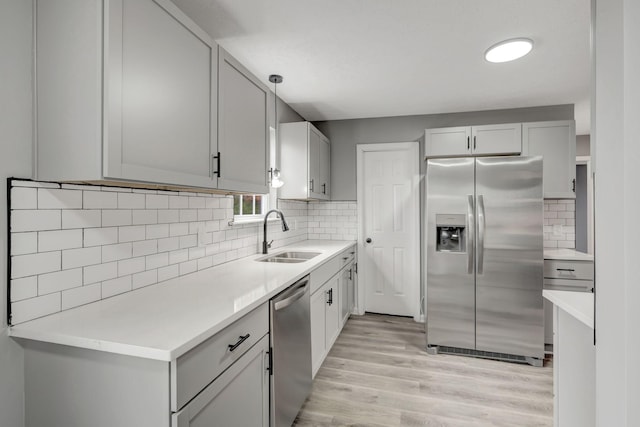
<box><xmin>279</xmin><ymin>122</ymin><xmax>331</xmax><ymax>200</ymax></box>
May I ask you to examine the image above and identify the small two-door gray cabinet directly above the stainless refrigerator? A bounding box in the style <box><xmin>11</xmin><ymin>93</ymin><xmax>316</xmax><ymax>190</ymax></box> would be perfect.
<box><xmin>423</xmin><ymin>123</ymin><xmax>522</xmax><ymax>158</ymax></box>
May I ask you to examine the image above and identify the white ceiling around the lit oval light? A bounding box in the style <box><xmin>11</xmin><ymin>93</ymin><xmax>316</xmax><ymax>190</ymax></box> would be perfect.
<box><xmin>173</xmin><ymin>0</ymin><xmax>590</xmax><ymax>135</ymax></box>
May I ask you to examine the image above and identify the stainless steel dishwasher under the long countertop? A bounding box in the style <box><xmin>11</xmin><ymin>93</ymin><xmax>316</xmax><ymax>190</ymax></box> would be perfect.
<box><xmin>270</xmin><ymin>276</ymin><xmax>311</xmax><ymax>427</ymax></box>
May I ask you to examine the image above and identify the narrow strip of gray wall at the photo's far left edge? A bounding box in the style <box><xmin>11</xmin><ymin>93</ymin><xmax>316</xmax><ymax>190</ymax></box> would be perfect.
<box><xmin>0</xmin><ymin>0</ymin><xmax>32</xmax><ymax>427</ymax></box>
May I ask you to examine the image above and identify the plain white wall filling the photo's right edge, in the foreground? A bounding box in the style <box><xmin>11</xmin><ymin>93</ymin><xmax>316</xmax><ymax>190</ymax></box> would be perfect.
<box><xmin>591</xmin><ymin>0</ymin><xmax>640</xmax><ymax>427</ymax></box>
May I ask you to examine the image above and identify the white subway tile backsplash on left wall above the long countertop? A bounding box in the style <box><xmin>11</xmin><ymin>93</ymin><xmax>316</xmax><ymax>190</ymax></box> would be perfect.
<box><xmin>10</xmin><ymin>181</ymin><xmax>310</xmax><ymax>323</ymax></box>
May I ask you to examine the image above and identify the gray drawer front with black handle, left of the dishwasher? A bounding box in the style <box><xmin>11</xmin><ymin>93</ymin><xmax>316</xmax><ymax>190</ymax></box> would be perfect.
<box><xmin>171</xmin><ymin>304</ymin><xmax>269</xmax><ymax>411</ymax></box>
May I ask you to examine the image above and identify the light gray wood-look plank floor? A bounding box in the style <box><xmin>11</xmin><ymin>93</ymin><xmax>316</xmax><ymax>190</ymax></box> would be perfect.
<box><xmin>294</xmin><ymin>314</ymin><xmax>553</xmax><ymax>427</ymax></box>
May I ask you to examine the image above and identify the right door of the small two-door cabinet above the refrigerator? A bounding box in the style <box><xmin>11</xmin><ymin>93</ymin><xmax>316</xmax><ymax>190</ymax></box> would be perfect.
<box><xmin>471</xmin><ymin>123</ymin><xmax>522</xmax><ymax>156</ymax></box>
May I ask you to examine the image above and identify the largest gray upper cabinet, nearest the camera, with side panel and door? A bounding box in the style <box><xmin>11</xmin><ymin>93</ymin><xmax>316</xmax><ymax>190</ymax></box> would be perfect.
<box><xmin>35</xmin><ymin>0</ymin><xmax>218</xmax><ymax>188</ymax></box>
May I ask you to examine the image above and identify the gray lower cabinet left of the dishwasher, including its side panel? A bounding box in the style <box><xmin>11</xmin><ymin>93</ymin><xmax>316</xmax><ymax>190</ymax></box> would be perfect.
<box><xmin>20</xmin><ymin>303</ymin><xmax>270</xmax><ymax>427</ymax></box>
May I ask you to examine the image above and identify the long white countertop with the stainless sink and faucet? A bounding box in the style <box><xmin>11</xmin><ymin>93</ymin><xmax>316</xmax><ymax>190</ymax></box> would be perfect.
<box><xmin>9</xmin><ymin>240</ymin><xmax>355</xmax><ymax>361</ymax></box>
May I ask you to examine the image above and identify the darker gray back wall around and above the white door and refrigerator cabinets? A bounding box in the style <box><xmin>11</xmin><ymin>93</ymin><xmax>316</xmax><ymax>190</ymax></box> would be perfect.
<box><xmin>316</xmin><ymin>105</ymin><xmax>573</xmax><ymax>200</ymax></box>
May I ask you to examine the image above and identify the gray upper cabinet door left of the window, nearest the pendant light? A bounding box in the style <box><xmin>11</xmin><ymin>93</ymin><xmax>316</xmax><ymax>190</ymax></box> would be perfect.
<box><xmin>215</xmin><ymin>48</ymin><xmax>269</xmax><ymax>194</ymax></box>
